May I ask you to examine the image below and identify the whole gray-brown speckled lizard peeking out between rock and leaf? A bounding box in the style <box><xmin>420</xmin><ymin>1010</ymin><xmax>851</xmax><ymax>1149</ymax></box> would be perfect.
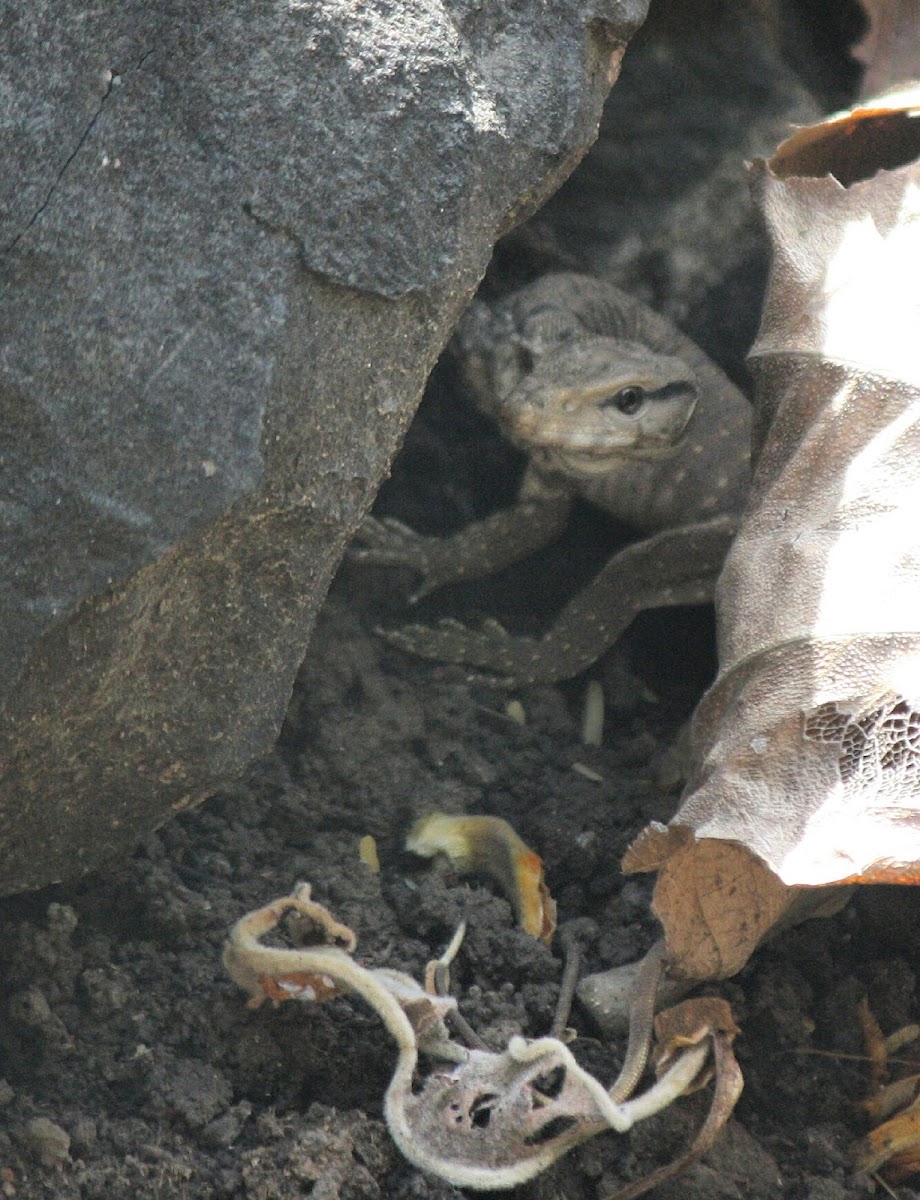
<box><xmin>353</xmin><ymin>274</ymin><xmax>751</xmax><ymax>683</ymax></box>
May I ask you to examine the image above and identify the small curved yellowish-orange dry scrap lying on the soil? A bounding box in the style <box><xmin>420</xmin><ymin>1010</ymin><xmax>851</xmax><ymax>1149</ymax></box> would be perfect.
<box><xmin>405</xmin><ymin>812</ymin><xmax>555</xmax><ymax>946</ymax></box>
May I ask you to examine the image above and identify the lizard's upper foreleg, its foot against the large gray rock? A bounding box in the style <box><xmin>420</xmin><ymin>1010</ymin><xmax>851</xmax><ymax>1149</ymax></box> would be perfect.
<box><xmin>349</xmin><ymin>468</ymin><xmax>572</xmax><ymax>602</ymax></box>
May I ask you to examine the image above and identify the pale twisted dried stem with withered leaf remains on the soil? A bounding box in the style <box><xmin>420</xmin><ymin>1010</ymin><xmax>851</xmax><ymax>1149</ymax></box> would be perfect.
<box><xmin>223</xmin><ymin>883</ymin><xmax>740</xmax><ymax>1195</ymax></box>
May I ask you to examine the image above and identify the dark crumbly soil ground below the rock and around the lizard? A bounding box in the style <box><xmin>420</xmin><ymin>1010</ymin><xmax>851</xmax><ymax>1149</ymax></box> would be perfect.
<box><xmin>0</xmin><ymin>0</ymin><xmax>920</xmax><ymax>1200</ymax></box>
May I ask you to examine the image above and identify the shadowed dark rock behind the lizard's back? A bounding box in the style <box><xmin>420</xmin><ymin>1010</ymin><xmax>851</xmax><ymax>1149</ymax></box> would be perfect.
<box><xmin>492</xmin><ymin>0</ymin><xmax>825</xmax><ymax>368</ymax></box>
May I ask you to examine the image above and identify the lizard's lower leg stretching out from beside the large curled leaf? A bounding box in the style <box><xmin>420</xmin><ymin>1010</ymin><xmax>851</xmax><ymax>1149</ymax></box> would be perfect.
<box><xmin>381</xmin><ymin>516</ymin><xmax>736</xmax><ymax>684</ymax></box>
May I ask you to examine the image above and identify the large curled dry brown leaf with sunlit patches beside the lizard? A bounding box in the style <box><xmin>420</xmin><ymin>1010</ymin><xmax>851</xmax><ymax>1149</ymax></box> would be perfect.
<box><xmin>624</xmin><ymin>88</ymin><xmax>920</xmax><ymax>979</ymax></box>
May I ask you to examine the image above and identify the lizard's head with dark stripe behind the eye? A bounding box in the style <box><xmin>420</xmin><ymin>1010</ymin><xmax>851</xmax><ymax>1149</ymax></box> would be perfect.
<box><xmin>493</xmin><ymin>337</ymin><xmax>699</xmax><ymax>475</ymax></box>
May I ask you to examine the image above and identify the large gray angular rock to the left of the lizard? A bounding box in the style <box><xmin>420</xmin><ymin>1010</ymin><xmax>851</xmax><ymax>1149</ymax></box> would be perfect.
<box><xmin>0</xmin><ymin>0</ymin><xmax>648</xmax><ymax>893</ymax></box>
